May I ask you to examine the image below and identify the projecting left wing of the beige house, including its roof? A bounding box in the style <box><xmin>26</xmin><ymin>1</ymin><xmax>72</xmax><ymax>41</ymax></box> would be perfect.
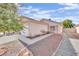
<box><xmin>20</xmin><ymin>16</ymin><xmax>49</xmax><ymax>37</ymax></box>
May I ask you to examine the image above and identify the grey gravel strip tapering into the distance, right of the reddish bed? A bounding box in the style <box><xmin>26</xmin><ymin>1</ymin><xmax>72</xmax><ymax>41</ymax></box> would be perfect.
<box><xmin>55</xmin><ymin>33</ymin><xmax>76</xmax><ymax>56</ymax></box>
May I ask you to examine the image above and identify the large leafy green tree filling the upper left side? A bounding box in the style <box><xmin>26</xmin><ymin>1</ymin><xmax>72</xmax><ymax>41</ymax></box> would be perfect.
<box><xmin>0</xmin><ymin>3</ymin><xmax>23</xmax><ymax>33</ymax></box>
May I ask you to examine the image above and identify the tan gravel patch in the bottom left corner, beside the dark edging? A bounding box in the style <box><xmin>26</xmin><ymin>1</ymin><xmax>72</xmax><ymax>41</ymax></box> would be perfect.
<box><xmin>0</xmin><ymin>40</ymin><xmax>24</xmax><ymax>56</ymax></box>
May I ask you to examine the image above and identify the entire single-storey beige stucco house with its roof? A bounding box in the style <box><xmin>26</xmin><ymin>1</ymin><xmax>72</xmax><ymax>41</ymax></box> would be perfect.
<box><xmin>20</xmin><ymin>17</ymin><xmax>63</xmax><ymax>37</ymax></box>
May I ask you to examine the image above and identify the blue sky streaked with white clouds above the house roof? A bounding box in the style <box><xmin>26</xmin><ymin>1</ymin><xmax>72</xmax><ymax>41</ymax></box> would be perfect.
<box><xmin>17</xmin><ymin>3</ymin><xmax>79</xmax><ymax>24</ymax></box>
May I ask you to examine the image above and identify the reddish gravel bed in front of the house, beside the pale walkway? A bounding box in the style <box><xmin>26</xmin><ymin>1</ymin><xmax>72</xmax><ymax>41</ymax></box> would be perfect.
<box><xmin>28</xmin><ymin>34</ymin><xmax>62</xmax><ymax>56</ymax></box>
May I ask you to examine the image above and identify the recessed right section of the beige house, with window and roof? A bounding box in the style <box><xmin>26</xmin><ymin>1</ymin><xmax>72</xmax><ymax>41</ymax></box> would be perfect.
<box><xmin>40</xmin><ymin>19</ymin><xmax>63</xmax><ymax>33</ymax></box>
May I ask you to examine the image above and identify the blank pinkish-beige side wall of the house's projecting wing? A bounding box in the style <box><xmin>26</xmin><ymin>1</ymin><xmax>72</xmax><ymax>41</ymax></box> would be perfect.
<box><xmin>29</xmin><ymin>23</ymin><xmax>48</xmax><ymax>36</ymax></box>
